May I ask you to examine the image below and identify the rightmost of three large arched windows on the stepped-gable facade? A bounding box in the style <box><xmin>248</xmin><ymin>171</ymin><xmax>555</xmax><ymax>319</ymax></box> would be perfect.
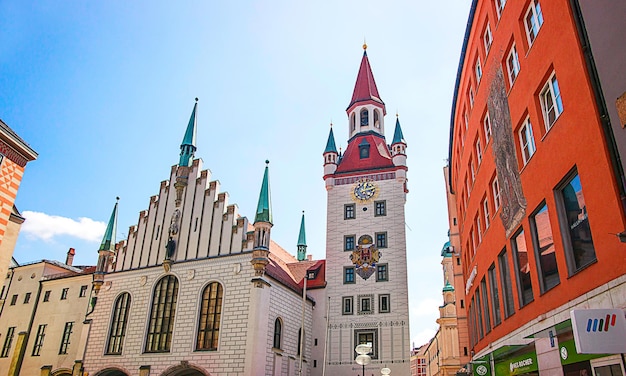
<box><xmin>196</xmin><ymin>282</ymin><xmax>224</xmax><ymax>350</ymax></box>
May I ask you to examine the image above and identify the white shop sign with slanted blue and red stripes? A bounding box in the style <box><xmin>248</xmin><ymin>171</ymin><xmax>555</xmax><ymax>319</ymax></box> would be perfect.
<box><xmin>570</xmin><ymin>308</ymin><xmax>626</xmax><ymax>354</ymax></box>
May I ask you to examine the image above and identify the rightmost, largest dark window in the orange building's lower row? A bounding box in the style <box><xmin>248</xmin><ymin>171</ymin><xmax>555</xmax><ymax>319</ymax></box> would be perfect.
<box><xmin>557</xmin><ymin>172</ymin><xmax>596</xmax><ymax>275</ymax></box>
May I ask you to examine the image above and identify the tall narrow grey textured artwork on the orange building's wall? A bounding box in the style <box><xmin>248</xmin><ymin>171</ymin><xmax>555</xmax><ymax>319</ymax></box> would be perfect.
<box><xmin>487</xmin><ymin>68</ymin><xmax>526</xmax><ymax>237</ymax></box>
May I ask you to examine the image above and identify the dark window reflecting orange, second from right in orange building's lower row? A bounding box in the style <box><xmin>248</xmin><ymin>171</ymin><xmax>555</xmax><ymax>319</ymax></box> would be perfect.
<box><xmin>529</xmin><ymin>202</ymin><xmax>560</xmax><ymax>293</ymax></box>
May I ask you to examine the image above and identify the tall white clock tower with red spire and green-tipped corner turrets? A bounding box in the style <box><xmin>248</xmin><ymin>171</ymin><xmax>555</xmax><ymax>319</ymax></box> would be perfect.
<box><xmin>323</xmin><ymin>45</ymin><xmax>410</xmax><ymax>375</ymax></box>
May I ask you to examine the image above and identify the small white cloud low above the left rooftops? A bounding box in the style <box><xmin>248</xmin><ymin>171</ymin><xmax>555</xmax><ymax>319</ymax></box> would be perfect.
<box><xmin>21</xmin><ymin>211</ymin><xmax>106</xmax><ymax>243</ymax></box>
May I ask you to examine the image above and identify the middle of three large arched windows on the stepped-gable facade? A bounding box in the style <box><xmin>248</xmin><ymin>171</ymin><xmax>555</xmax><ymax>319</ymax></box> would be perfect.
<box><xmin>146</xmin><ymin>275</ymin><xmax>178</xmax><ymax>352</ymax></box>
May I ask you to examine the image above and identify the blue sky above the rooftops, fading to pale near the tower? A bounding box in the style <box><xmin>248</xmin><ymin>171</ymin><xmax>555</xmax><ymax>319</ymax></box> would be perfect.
<box><xmin>0</xmin><ymin>0</ymin><xmax>470</xmax><ymax>345</ymax></box>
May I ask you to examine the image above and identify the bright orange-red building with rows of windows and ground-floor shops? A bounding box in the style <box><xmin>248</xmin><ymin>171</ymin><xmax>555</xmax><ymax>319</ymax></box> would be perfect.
<box><xmin>448</xmin><ymin>0</ymin><xmax>626</xmax><ymax>376</ymax></box>
